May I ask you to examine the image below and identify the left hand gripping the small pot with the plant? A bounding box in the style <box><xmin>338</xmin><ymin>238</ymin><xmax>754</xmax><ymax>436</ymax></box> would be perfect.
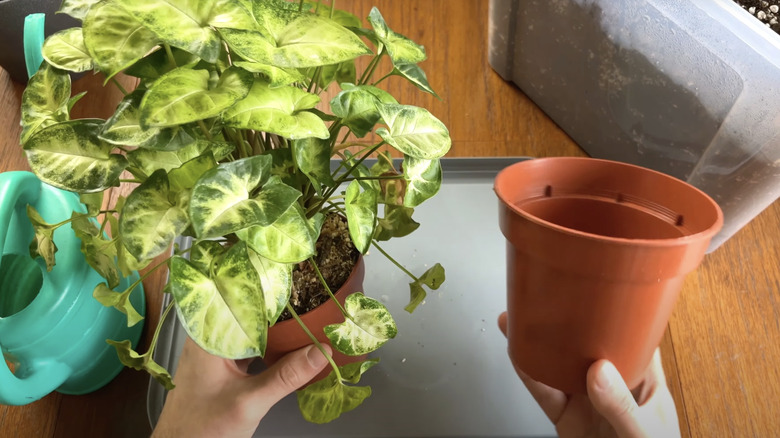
<box><xmin>152</xmin><ymin>337</ymin><xmax>331</xmax><ymax>438</ymax></box>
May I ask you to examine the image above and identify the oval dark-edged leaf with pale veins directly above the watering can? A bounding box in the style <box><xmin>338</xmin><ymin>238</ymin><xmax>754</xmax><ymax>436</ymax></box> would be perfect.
<box><xmin>24</xmin><ymin>119</ymin><xmax>127</xmax><ymax>193</ymax></box>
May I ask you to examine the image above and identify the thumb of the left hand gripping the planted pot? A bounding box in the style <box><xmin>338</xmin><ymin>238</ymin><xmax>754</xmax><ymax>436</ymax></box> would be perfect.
<box><xmin>244</xmin><ymin>345</ymin><xmax>331</xmax><ymax>412</ymax></box>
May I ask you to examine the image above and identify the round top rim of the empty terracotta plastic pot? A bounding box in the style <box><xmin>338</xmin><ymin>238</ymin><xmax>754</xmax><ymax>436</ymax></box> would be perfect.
<box><xmin>493</xmin><ymin>157</ymin><xmax>724</xmax><ymax>247</ymax></box>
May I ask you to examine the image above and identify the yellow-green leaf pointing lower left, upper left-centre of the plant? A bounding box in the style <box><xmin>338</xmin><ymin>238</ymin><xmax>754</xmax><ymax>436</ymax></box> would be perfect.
<box><xmin>141</xmin><ymin>67</ymin><xmax>252</xmax><ymax>126</ymax></box>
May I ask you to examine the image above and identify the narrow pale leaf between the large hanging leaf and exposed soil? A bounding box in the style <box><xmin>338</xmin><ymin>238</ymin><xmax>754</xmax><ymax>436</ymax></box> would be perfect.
<box><xmin>248</xmin><ymin>249</ymin><xmax>293</xmax><ymax>325</ymax></box>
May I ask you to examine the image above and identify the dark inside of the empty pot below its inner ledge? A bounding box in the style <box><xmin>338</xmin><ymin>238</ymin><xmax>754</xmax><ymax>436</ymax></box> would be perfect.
<box><xmin>518</xmin><ymin>197</ymin><xmax>686</xmax><ymax>239</ymax></box>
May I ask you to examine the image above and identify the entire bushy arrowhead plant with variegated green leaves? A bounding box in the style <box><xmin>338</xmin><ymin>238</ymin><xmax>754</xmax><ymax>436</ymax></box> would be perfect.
<box><xmin>20</xmin><ymin>0</ymin><xmax>451</xmax><ymax>423</ymax></box>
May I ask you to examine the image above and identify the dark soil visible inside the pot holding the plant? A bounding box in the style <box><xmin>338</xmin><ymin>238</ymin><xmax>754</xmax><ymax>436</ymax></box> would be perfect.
<box><xmin>279</xmin><ymin>214</ymin><xmax>360</xmax><ymax>321</ymax></box>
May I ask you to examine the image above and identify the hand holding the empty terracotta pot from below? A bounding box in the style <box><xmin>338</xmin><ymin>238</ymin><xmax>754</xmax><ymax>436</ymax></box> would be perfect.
<box><xmin>498</xmin><ymin>312</ymin><xmax>680</xmax><ymax>438</ymax></box>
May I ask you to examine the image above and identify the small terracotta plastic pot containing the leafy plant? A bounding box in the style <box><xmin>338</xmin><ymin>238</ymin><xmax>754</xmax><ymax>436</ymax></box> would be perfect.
<box><xmin>263</xmin><ymin>256</ymin><xmax>366</xmax><ymax>381</ymax></box>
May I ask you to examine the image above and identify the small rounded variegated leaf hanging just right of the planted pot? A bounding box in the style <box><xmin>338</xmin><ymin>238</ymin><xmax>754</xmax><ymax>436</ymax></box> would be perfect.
<box><xmin>324</xmin><ymin>292</ymin><xmax>398</xmax><ymax>356</ymax></box>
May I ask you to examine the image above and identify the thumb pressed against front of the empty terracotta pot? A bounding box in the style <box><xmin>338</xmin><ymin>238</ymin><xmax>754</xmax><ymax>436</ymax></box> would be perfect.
<box><xmin>587</xmin><ymin>360</ymin><xmax>646</xmax><ymax>438</ymax></box>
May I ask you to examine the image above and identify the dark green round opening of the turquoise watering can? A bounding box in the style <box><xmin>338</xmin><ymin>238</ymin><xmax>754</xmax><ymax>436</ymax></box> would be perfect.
<box><xmin>0</xmin><ymin>254</ymin><xmax>43</xmax><ymax>318</ymax></box>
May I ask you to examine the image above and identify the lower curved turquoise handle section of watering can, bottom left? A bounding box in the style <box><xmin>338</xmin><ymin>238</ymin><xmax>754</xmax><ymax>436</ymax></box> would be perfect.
<box><xmin>0</xmin><ymin>346</ymin><xmax>71</xmax><ymax>406</ymax></box>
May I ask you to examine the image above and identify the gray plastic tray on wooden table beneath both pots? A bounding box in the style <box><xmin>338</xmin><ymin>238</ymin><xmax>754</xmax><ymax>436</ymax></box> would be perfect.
<box><xmin>148</xmin><ymin>158</ymin><xmax>555</xmax><ymax>437</ymax></box>
